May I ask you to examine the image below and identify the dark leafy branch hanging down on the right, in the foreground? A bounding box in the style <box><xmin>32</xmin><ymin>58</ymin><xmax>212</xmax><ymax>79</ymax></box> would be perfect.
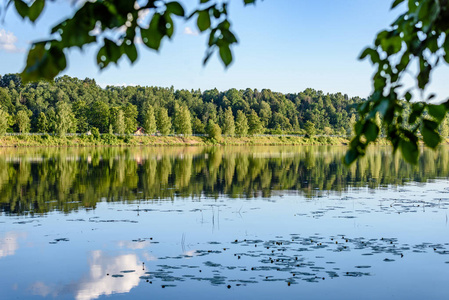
<box><xmin>345</xmin><ymin>0</ymin><xmax>449</xmax><ymax>164</ymax></box>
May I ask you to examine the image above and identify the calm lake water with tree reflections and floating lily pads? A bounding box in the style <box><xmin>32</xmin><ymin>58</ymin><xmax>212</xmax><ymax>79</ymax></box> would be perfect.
<box><xmin>0</xmin><ymin>147</ymin><xmax>449</xmax><ymax>300</ymax></box>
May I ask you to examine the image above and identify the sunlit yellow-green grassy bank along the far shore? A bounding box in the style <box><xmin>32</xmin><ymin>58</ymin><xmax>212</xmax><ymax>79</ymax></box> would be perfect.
<box><xmin>0</xmin><ymin>134</ymin><xmax>356</xmax><ymax>147</ymax></box>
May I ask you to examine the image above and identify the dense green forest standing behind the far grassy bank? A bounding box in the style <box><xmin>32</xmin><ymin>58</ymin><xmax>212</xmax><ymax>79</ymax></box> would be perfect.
<box><xmin>0</xmin><ymin>74</ymin><xmax>362</xmax><ymax>137</ymax></box>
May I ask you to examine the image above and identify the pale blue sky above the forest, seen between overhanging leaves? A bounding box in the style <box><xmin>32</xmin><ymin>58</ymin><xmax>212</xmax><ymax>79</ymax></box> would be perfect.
<box><xmin>0</xmin><ymin>0</ymin><xmax>449</xmax><ymax>97</ymax></box>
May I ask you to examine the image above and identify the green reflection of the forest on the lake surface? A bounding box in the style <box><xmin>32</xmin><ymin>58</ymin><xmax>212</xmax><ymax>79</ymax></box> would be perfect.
<box><xmin>0</xmin><ymin>146</ymin><xmax>449</xmax><ymax>214</ymax></box>
